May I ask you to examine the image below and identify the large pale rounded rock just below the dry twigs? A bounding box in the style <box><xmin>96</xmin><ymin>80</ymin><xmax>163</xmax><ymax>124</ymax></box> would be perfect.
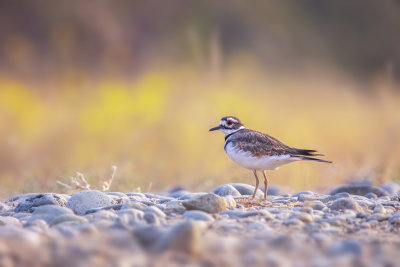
<box><xmin>67</xmin><ymin>190</ymin><xmax>113</xmax><ymax>215</ymax></box>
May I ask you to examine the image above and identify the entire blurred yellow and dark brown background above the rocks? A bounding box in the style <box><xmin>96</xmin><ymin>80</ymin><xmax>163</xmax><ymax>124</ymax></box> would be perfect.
<box><xmin>0</xmin><ymin>0</ymin><xmax>400</xmax><ymax>198</ymax></box>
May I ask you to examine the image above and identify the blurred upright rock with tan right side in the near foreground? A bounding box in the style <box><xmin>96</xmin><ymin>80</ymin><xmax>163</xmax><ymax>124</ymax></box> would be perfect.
<box><xmin>155</xmin><ymin>220</ymin><xmax>201</xmax><ymax>256</ymax></box>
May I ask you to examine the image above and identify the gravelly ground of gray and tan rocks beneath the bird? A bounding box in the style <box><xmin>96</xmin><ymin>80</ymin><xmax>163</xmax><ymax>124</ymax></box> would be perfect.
<box><xmin>0</xmin><ymin>183</ymin><xmax>400</xmax><ymax>266</ymax></box>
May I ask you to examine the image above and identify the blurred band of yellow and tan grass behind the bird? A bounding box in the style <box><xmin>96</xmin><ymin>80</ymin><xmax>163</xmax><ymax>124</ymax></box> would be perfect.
<box><xmin>0</xmin><ymin>63</ymin><xmax>400</xmax><ymax>199</ymax></box>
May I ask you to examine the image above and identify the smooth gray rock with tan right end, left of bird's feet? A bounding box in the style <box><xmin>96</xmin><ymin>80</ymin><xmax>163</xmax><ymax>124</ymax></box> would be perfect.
<box><xmin>182</xmin><ymin>193</ymin><xmax>226</xmax><ymax>213</ymax></box>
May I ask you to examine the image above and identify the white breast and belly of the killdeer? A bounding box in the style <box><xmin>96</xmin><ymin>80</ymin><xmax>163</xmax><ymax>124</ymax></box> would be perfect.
<box><xmin>226</xmin><ymin>143</ymin><xmax>300</xmax><ymax>171</ymax></box>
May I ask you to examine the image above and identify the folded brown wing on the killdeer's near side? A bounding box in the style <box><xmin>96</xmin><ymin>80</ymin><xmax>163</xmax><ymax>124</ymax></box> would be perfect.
<box><xmin>227</xmin><ymin>129</ymin><xmax>294</xmax><ymax>157</ymax></box>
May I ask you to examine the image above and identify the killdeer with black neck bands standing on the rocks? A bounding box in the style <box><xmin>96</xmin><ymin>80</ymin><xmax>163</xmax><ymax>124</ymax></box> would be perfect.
<box><xmin>210</xmin><ymin>116</ymin><xmax>332</xmax><ymax>200</ymax></box>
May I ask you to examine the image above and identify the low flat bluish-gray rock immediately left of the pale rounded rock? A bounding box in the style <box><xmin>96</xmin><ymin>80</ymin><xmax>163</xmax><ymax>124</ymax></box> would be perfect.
<box><xmin>14</xmin><ymin>193</ymin><xmax>67</xmax><ymax>212</ymax></box>
